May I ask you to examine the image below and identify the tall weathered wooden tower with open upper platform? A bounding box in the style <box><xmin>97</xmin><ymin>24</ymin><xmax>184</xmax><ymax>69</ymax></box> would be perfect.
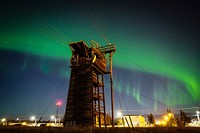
<box><xmin>63</xmin><ymin>41</ymin><xmax>116</xmax><ymax>127</ymax></box>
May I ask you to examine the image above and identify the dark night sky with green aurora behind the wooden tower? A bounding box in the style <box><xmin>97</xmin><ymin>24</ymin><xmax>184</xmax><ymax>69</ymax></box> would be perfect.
<box><xmin>0</xmin><ymin>0</ymin><xmax>200</xmax><ymax>118</ymax></box>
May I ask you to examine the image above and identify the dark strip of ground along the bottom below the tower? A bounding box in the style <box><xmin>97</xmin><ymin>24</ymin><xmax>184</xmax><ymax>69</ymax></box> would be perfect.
<box><xmin>0</xmin><ymin>126</ymin><xmax>200</xmax><ymax>133</ymax></box>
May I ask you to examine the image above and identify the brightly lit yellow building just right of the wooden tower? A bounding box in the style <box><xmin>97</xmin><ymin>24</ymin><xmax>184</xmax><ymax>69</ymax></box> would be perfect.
<box><xmin>122</xmin><ymin>115</ymin><xmax>146</xmax><ymax>127</ymax></box>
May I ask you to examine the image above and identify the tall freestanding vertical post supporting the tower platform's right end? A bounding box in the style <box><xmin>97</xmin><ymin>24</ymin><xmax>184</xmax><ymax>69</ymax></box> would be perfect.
<box><xmin>109</xmin><ymin>53</ymin><xmax>114</xmax><ymax>127</ymax></box>
